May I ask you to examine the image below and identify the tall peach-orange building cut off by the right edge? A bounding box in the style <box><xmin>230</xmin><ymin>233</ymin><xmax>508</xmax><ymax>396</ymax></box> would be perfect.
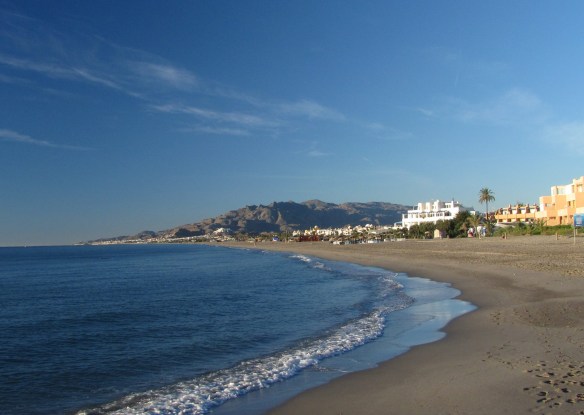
<box><xmin>536</xmin><ymin>176</ymin><xmax>584</xmax><ymax>226</ymax></box>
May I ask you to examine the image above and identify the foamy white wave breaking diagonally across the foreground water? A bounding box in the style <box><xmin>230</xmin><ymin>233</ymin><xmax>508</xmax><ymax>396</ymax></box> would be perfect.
<box><xmin>78</xmin><ymin>301</ymin><xmax>410</xmax><ymax>415</ymax></box>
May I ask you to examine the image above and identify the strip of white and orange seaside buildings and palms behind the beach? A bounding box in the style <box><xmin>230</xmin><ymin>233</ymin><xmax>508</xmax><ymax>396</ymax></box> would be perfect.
<box><xmin>89</xmin><ymin>176</ymin><xmax>584</xmax><ymax>245</ymax></box>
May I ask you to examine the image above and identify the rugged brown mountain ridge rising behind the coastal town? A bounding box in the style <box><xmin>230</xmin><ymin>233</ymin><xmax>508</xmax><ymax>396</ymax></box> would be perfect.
<box><xmin>92</xmin><ymin>200</ymin><xmax>410</xmax><ymax>242</ymax></box>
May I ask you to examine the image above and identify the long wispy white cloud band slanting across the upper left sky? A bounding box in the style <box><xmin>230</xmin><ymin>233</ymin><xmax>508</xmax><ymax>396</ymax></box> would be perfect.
<box><xmin>0</xmin><ymin>42</ymin><xmax>346</xmax><ymax>135</ymax></box>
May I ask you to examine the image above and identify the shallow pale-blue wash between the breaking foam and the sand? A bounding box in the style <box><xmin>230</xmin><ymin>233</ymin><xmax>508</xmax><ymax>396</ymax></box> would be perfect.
<box><xmin>212</xmin><ymin>260</ymin><xmax>476</xmax><ymax>415</ymax></box>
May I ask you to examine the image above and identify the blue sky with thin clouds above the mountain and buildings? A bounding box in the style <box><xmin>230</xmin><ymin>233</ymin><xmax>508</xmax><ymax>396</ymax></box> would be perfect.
<box><xmin>0</xmin><ymin>0</ymin><xmax>584</xmax><ymax>246</ymax></box>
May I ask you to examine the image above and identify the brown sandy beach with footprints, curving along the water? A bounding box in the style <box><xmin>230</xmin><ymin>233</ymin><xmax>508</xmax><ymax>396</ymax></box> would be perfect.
<box><xmin>227</xmin><ymin>236</ymin><xmax>584</xmax><ymax>415</ymax></box>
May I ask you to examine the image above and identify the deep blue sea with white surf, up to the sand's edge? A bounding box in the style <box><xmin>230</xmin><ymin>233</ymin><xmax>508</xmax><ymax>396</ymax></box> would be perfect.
<box><xmin>0</xmin><ymin>242</ymin><xmax>474</xmax><ymax>415</ymax></box>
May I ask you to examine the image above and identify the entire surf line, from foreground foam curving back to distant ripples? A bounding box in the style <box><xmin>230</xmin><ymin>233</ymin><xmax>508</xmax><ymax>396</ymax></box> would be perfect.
<box><xmin>78</xmin><ymin>254</ymin><xmax>414</xmax><ymax>415</ymax></box>
